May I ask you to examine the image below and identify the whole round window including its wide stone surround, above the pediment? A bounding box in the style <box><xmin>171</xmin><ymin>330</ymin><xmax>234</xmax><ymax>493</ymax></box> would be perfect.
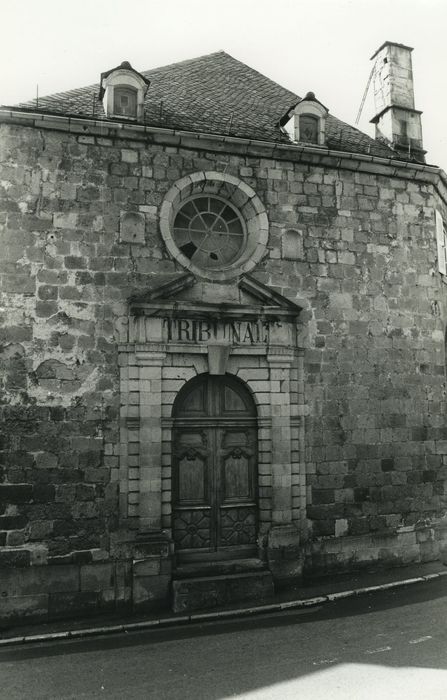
<box><xmin>160</xmin><ymin>171</ymin><xmax>269</xmax><ymax>282</ymax></box>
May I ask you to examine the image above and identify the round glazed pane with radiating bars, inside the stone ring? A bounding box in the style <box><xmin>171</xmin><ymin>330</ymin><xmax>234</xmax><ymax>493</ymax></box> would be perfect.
<box><xmin>173</xmin><ymin>196</ymin><xmax>245</xmax><ymax>269</ymax></box>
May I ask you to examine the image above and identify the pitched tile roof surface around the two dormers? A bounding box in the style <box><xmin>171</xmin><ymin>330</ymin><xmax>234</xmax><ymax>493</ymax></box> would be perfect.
<box><xmin>10</xmin><ymin>51</ymin><xmax>397</xmax><ymax>158</ymax></box>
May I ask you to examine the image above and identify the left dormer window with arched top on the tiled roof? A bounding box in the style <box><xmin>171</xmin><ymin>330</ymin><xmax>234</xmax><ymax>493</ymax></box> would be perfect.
<box><xmin>99</xmin><ymin>61</ymin><xmax>150</xmax><ymax>121</ymax></box>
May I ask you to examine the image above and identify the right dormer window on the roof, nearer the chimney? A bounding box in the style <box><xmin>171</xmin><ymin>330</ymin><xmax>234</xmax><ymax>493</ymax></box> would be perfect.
<box><xmin>281</xmin><ymin>92</ymin><xmax>329</xmax><ymax>146</ymax></box>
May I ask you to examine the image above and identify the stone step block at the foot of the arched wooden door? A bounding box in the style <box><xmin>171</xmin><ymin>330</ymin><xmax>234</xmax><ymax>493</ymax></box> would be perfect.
<box><xmin>172</xmin><ymin>571</ymin><xmax>274</xmax><ymax>612</ymax></box>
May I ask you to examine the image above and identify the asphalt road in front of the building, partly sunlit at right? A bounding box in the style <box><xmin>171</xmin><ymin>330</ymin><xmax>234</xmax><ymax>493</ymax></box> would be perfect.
<box><xmin>0</xmin><ymin>578</ymin><xmax>447</xmax><ymax>700</ymax></box>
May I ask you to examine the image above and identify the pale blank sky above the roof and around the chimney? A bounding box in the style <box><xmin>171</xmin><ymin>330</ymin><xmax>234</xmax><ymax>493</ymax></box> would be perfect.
<box><xmin>0</xmin><ymin>0</ymin><xmax>447</xmax><ymax>170</ymax></box>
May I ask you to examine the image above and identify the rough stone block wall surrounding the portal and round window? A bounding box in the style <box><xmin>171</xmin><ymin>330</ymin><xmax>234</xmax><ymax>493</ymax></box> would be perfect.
<box><xmin>0</xmin><ymin>120</ymin><xmax>447</xmax><ymax>616</ymax></box>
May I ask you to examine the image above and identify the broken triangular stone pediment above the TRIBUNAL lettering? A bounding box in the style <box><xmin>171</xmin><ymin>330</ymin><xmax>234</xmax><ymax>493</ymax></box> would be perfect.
<box><xmin>129</xmin><ymin>273</ymin><xmax>302</xmax><ymax>317</ymax></box>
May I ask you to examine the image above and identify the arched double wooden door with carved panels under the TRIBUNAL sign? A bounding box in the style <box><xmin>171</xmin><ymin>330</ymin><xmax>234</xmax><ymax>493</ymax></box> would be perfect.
<box><xmin>172</xmin><ymin>374</ymin><xmax>258</xmax><ymax>561</ymax></box>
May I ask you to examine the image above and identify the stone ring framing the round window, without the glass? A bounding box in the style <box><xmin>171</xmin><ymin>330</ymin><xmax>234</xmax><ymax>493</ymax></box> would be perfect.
<box><xmin>160</xmin><ymin>171</ymin><xmax>269</xmax><ymax>282</ymax></box>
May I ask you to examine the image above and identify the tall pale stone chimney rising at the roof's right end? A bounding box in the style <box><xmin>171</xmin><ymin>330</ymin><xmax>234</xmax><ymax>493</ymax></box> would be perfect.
<box><xmin>371</xmin><ymin>41</ymin><xmax>426</xmax><ymax>163</ymax></box>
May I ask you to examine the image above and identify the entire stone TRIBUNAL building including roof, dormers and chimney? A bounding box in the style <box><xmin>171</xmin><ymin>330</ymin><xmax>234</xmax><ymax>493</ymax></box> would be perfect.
<box><xmin>0</xmin><ymin>43</ymin><xmax>447</xmax><ymax>618</ymax></box>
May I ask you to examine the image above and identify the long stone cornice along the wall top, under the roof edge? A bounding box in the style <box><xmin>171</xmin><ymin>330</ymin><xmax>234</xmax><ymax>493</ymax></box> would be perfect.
<box><xmin>0</xmin><ymin>109</ymin><xmax>447</xmax><ymax>205</ymax></box>
